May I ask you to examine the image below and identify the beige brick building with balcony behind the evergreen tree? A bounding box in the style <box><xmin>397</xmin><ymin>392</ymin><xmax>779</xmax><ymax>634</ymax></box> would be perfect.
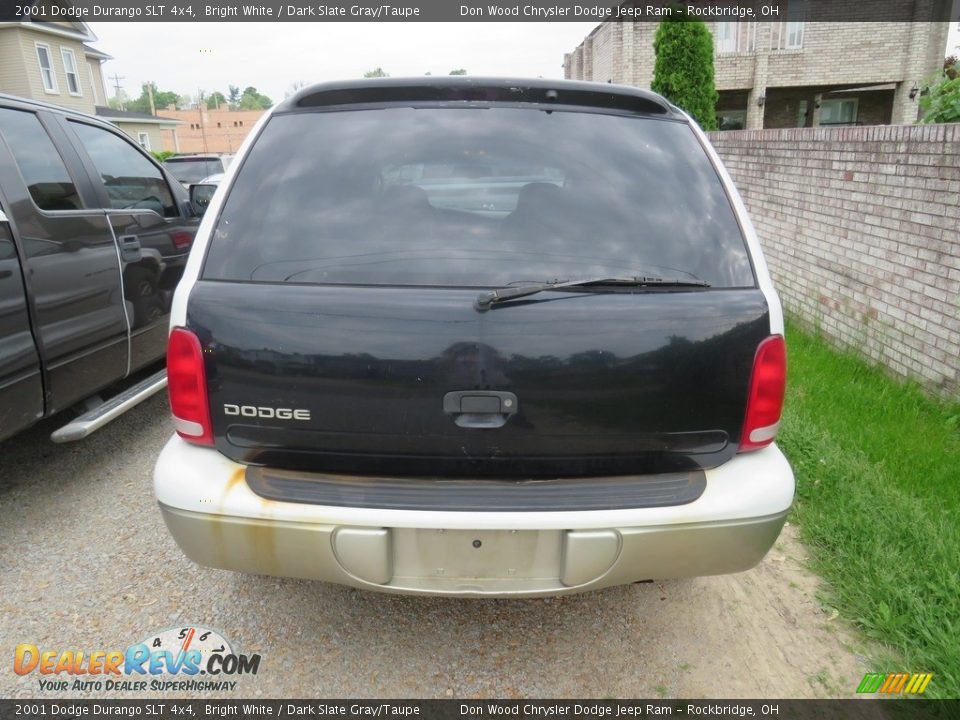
<box><xmin>564</xmin><ymin>11</ymin><xmax>949</xmax><ymax>129</ymax></box>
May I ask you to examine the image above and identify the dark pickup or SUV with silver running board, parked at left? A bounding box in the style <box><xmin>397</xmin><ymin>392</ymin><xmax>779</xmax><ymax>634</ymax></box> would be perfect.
<box><xmin>0</xmin><ymin>95</ymin><xmax>197</xmax><ymax>440</ymax></box>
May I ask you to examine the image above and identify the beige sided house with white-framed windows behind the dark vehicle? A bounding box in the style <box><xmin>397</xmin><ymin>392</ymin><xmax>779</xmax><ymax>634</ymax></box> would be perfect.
<box><xmin>0</xmin><ymin>15</ymin><xmax>179</xmax><ymax>150</ymax></box>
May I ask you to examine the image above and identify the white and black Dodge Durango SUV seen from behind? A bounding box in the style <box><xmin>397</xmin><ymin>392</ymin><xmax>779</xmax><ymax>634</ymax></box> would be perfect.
<box><xmin>155</xmin><ymin>78</ymin><xmax>794</xmax><ymax>596</ymax></box>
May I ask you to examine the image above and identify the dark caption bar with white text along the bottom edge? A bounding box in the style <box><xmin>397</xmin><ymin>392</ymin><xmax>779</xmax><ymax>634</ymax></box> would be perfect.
<box><xmin>0</xmin><ymin>698</ymin><xmax>960</xmax><ymax>720</ymax></box>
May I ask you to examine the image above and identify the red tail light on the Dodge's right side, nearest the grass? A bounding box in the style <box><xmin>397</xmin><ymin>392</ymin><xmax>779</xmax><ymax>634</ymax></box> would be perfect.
<box><xmin>739</xmin><ymin>335</ymin><xmax>787</xmax><ymax>452</ymax></box>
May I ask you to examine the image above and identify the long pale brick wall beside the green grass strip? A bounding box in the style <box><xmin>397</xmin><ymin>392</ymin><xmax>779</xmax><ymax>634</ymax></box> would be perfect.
<box><xmin>711</xmin><ymin>125</ymin><xmax>960</xmax><ymax>395</ymax></box>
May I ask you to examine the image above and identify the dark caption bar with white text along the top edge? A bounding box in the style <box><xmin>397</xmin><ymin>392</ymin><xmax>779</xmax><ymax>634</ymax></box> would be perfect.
<box><xmin>0</xmin><ymin>0</ymin><xmax>960</xmax><ymax>22</ymax></box>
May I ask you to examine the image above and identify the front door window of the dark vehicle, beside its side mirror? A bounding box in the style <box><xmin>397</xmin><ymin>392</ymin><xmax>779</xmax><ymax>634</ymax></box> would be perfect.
<box><xmin>71</xmin><ymin>121</ymin><xmax>178</xmax><ymax>217</ymax></box>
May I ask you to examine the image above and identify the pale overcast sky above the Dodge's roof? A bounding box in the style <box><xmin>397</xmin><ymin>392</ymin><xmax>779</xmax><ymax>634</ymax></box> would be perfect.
<box><xmin>90</xmin><ymin>22</ymin><xmax>960</xmax><ymax>106</ymax></box>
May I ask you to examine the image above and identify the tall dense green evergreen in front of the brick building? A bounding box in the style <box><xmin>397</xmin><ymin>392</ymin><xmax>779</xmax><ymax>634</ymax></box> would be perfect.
<box><xmin>651</xmin><ymin>12</ymin><xmax>718</xmax><ymax>130</ymax></box>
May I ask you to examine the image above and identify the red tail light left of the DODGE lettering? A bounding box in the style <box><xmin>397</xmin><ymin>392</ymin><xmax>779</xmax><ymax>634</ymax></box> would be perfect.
<box><xmin>167</xmin><ymin>328</ymin><xmax>213</xmax><ymax>445</ymax></box>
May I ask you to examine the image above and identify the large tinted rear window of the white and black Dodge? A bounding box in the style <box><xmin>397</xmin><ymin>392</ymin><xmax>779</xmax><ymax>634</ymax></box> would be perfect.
<box><xmin>203</xmin><ymin>107</ymin><xmax>755</xmax><ymax>287</ymax></box>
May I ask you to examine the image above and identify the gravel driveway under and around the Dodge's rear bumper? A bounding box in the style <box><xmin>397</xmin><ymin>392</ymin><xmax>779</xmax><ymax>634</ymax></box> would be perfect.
<box><xmin>0</xmin><ymin>395</ymin><xmax>865</xmax><ymax>698</ymax></box>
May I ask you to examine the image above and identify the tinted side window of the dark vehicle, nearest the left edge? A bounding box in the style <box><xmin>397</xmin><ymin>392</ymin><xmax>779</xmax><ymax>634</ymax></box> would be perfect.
<box><xmin>0</xmin><ymin>108</ymin><xmax>82</xmax><ymax>210</ymax></box>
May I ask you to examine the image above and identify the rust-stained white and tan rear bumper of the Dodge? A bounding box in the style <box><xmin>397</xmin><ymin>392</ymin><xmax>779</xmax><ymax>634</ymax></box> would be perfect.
<box><xmin>154</xmin><ymin>437</ymin><xmax>794</xmax><ymax>597</ymax></box>
